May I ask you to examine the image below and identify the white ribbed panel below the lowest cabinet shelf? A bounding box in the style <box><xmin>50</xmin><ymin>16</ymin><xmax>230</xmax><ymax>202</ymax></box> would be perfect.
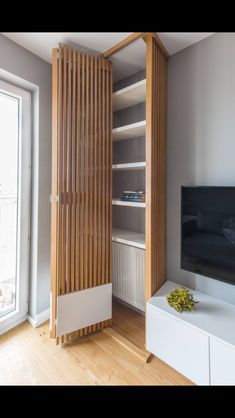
<box><xmin>113</xmin><ymin>242</ymin><xmax>145</xmax><ymax>311</ymax></box>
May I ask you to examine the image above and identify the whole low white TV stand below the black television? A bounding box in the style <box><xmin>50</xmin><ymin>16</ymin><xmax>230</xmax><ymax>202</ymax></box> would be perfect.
<box><xmin>146</xmin><ymin>281</ymin><xmax>235</xmax><ymax>385</ymax></box>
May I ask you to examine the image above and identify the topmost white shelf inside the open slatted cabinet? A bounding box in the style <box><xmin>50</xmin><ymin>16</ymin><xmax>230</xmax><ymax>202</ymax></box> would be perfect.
<box><xmin>113</xmin><ymin>79</ymin><xmax>146</xmax><ymax>112</ymax></box>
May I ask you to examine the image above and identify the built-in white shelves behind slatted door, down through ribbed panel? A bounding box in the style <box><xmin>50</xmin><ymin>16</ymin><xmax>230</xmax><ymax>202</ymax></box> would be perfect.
<box><xmin>112</xmin><ymin>74</ymin><xmax>146</xmax><ymax>311</ymax></box>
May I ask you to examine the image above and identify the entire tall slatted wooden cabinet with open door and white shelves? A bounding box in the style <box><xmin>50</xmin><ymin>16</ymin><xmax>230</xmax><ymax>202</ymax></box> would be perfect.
<box><xmin>50</xmin><ymin>32</ymin><xmax>169</xmax><ymax>342</ymax></box>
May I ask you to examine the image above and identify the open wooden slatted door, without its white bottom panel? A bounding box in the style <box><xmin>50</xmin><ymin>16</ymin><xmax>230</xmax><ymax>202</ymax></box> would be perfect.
<box><xmin>51</xmin><ymin>47</ymin><xmax>112</xmax><ymax>342</ymax></box>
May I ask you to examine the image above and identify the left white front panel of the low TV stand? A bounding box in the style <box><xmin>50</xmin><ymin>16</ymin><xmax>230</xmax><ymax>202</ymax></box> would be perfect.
<box><xmin>146</xmin><ymin>304</ymin><xmax>209</xmax><ymax>385</ymax></box>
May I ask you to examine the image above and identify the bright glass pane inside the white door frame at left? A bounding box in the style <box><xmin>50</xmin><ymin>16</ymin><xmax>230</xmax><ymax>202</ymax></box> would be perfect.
<box><xmin>0</xmin><ymin>92</ymin><xmax>19</xmax><ymax>317</ymax></box>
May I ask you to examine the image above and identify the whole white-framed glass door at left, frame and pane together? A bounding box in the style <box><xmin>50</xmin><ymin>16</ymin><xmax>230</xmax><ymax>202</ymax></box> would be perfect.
<box><xmin>0</xmin><ymin>79</ymin><xmax>31</xmax><ymax>335</ymax></box>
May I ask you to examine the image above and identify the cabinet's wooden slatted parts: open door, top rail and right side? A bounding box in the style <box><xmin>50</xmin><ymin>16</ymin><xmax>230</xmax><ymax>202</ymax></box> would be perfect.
<box><xmin>51</xmin><ymin>32</ymin><xmax>168</xmax><ymax>342</ymax></box>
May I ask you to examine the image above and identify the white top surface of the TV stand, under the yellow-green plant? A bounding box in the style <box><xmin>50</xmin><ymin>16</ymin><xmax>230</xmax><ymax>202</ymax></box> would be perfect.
<box><xmin>148</xmin><ymin>280</ymin><xmax>235</xmax><ymax>347</ymax></box>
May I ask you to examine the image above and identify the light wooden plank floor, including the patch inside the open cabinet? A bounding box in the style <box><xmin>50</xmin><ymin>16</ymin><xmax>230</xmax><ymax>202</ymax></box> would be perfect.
<box><xmin>0</xmin><ymin>303</ymin><xmax>192</xmax><ymax>385</ymax></box>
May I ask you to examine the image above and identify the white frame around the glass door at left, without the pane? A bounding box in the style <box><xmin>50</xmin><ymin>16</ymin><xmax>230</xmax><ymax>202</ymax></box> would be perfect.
<box><xmin>0</xmin><ymin>79</ymin><xmax>31</xmax><ymax>335</ymax></box>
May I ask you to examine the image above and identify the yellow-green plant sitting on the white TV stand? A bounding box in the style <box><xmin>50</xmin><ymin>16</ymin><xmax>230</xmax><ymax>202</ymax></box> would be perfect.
<box><xmin>166</xmin><ymin>287</ymin><xmax>198</xmax><ymax>313</ymax></box>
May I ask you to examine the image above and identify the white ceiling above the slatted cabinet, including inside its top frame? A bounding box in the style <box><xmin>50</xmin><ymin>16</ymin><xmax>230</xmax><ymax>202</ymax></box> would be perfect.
<box><xmin>2</xmin><ymin>32</ymin><xmax>213</xmax><ymax>81</ymax></box>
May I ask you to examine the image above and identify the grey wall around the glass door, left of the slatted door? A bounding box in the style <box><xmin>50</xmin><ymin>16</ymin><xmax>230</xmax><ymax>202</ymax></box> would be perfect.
<box><xmin>0</xmin><ymin>35</ymin><xmax>51</xmax><ymax>319</ymax></box>
